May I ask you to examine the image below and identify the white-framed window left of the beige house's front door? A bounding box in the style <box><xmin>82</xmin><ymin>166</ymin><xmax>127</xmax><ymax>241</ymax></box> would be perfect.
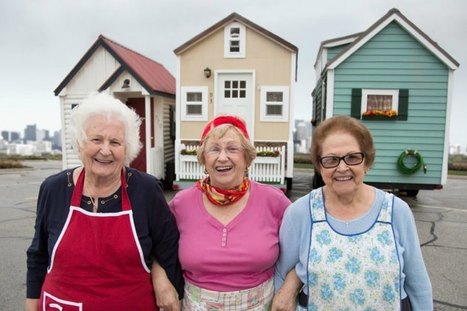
<box><xmin>181</xmin><ymin>87</ymin><xmax>208</xmax><ymax>121</ymax></box>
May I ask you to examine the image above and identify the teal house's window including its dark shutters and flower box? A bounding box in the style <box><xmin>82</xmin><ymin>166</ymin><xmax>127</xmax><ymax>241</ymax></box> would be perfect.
<box><xmin>351</xmin><ymin>89</ymin><xmax>409</xmax><ymax>120</ymax></box>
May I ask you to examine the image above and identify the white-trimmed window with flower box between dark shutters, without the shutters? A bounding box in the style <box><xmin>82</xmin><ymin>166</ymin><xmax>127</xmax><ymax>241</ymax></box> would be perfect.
<box><xmin>361</xmin><ymin>89</ymin><xmax>399</xmax><ymax>116</ymax></box>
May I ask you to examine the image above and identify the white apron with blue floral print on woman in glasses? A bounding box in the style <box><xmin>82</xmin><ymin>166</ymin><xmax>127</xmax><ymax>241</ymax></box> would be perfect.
<box><xmin>308</xmin><ymin>188</ymin><xmax>401</xmax><ymax>311</ymax></box>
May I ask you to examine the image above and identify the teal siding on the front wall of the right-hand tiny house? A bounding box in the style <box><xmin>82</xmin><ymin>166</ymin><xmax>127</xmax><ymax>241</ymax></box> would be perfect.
<box><xmin>333</xmin><ymin>22</ymin><xmax>449</xmax><ymax>184</ymax></box>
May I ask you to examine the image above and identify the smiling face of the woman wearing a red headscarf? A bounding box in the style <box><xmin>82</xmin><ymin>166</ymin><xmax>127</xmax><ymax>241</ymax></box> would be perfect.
<box><xmin>204</xmin><ymin>129</ymin><xmax>247</xmax><ymax>189</ymax></box>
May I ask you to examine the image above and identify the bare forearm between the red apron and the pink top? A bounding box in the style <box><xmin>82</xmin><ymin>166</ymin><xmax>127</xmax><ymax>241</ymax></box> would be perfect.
<box><xmin>151</xmin><ymin>260</ymin><xmax>181</xmax><ymax>311</ymax></box>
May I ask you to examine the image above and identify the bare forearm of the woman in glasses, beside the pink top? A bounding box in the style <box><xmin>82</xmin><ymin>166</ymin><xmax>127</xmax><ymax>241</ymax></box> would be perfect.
<box><xmin>271</xmin><ymin>269</ymin><xmax>303</xmax><ymax>311</ymax></box>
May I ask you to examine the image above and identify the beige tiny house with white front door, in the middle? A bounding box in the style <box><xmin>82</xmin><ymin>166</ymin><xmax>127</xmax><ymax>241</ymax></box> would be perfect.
<box><xmin>174</xmin><ymin>13</ymin><xmax>298</xmax><ymax>190</ymax></box>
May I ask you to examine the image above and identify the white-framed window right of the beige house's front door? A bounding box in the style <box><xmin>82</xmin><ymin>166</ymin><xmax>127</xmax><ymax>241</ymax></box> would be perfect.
<box><xmin>260</xmin><ymin>86</ymin><xmax>289</xmax><ymax>122</ymax></box>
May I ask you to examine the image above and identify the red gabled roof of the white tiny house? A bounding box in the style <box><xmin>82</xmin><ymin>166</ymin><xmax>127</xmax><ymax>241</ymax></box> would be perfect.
<box><xmin>54</xmin><ymin>35</ymin><xmax>175</xmax><ymax>96</ymax></box>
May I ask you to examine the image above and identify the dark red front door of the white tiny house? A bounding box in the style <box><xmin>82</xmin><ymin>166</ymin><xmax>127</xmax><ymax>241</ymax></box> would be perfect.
<box><xmin>126</xmin><ymin>98</ymin><xmax>154</xmax><ymax>172</ymax></box>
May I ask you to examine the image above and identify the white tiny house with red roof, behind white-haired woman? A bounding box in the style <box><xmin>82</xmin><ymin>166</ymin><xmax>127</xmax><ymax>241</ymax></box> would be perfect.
<box><xmin>54</xmin><ymin>35</ymin><xmax>175</xmax><ymax>188</ymax></box>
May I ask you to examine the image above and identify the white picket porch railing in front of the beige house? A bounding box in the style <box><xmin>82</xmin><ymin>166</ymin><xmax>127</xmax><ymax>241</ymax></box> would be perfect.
<box><xmin>177</xmin><ymin>146</ymin><xmax>285</xmax><ymax>184</ymax></box>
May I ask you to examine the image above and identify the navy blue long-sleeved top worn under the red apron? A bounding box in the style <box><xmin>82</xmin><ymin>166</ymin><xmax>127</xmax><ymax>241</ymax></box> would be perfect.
<box><xmin>26</xmin><ymin>167</ymin><xmax>183</xmax><ymax>299</ymax></box>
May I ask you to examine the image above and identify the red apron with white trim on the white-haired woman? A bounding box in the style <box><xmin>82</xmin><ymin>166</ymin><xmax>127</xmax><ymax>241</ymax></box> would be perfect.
<box><xmin>39</xmin><ymin>169</ymin><xmax>159</xmax><ymax>311</ymax></box>
